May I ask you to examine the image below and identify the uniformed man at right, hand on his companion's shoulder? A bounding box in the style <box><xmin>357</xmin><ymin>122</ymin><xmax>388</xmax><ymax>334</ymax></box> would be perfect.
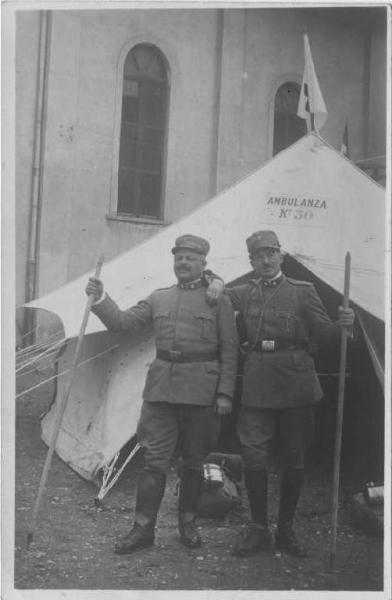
<box><xmin>209</xmin><ymin>231</ymin><xmax>354</xmax><ymax>556</ymax></box>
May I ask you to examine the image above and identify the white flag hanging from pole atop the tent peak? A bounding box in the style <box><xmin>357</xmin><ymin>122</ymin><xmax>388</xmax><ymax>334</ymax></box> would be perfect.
<box><xmin>297</xmin><ymin>33</ymin><xmax>328</xmax><ymax>132</ymax></box>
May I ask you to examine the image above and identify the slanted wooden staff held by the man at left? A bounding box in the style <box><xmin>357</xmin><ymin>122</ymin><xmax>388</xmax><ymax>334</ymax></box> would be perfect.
<box><xmin>26</xmin><ymin>256</ymin><xmax>103</xmax><ymax>548</ymax></box>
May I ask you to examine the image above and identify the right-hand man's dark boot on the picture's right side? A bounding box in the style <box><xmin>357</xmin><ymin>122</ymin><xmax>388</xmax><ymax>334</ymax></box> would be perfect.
<box><xmin>275</xmin><ymin>468</ymin><xmax>307</xmax><ymax>558</ymax></box>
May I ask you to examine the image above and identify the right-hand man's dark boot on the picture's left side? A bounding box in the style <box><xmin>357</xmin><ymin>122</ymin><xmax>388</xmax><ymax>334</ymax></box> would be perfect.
<box><xmin>233</xmin><ymin>469</ymin><xmax>271</xmax><ymax>556</ymax></box>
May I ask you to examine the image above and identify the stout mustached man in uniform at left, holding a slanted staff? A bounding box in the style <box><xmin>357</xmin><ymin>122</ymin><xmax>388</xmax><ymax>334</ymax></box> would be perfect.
<box><xmin>86</xmin><ymin>235</ymin><xmax>238</xmax><ymax>554</ymax></box>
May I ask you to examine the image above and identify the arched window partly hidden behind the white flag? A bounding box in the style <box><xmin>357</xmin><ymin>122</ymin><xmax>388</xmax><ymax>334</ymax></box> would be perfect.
<box><xmin>273</xmin><ymin>81</ymin><xmax>306</xmax><ymax>155</ymax></box>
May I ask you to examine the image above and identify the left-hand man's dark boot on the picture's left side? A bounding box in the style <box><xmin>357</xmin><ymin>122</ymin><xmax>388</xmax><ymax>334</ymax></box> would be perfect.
<box><xmin>114</xmin><ymin>469</ymin><xmax>166</xmax><ymax>554</ymax></box>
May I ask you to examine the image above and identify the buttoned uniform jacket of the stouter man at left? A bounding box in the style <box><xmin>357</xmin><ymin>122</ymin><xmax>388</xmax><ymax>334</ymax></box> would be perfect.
<box><xmin>92</xmin><ymin>284</ymin><xmax>238</xmax><ymax>406</ymax></box>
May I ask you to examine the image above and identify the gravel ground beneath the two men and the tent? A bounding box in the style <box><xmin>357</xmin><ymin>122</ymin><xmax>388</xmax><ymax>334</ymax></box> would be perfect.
<box><xmin>14</xmin><ymin>364</ymin><xmax>383</xmax><ymax>598</ymax></box>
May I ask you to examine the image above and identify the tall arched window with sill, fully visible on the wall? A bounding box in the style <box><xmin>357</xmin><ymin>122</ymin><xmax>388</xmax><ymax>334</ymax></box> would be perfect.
<box><xmin>117</xmin><ymin>44</ymin><xmax>168</xmax><ymax>219</ymax></box>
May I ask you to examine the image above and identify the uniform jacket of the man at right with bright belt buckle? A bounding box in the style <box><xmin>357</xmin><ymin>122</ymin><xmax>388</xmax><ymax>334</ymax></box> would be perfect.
<box><xmin>227</xmin><ymin>275</ymin><xmax>340</xmax><ymax>409</ymax></box>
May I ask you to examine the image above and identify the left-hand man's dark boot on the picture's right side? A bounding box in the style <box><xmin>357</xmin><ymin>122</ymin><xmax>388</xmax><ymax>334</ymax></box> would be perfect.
<box><xmin>178</xmin><ymin>469</ymin><xmax>203</xmax><ymax>548</ymax></box>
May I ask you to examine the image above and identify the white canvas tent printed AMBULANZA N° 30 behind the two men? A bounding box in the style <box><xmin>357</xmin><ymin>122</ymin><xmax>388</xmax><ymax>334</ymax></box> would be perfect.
<box><xmin>25</xmin><ymin>134</ymin><xmax>385</xmax><ymax>488</ymax></box>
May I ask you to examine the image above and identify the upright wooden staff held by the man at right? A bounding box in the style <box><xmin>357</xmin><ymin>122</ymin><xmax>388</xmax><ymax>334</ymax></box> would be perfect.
<box><xmin>329</xmin><ymin>252</ymin><xmax>351</xmax><ymax>568</ymax></box>
